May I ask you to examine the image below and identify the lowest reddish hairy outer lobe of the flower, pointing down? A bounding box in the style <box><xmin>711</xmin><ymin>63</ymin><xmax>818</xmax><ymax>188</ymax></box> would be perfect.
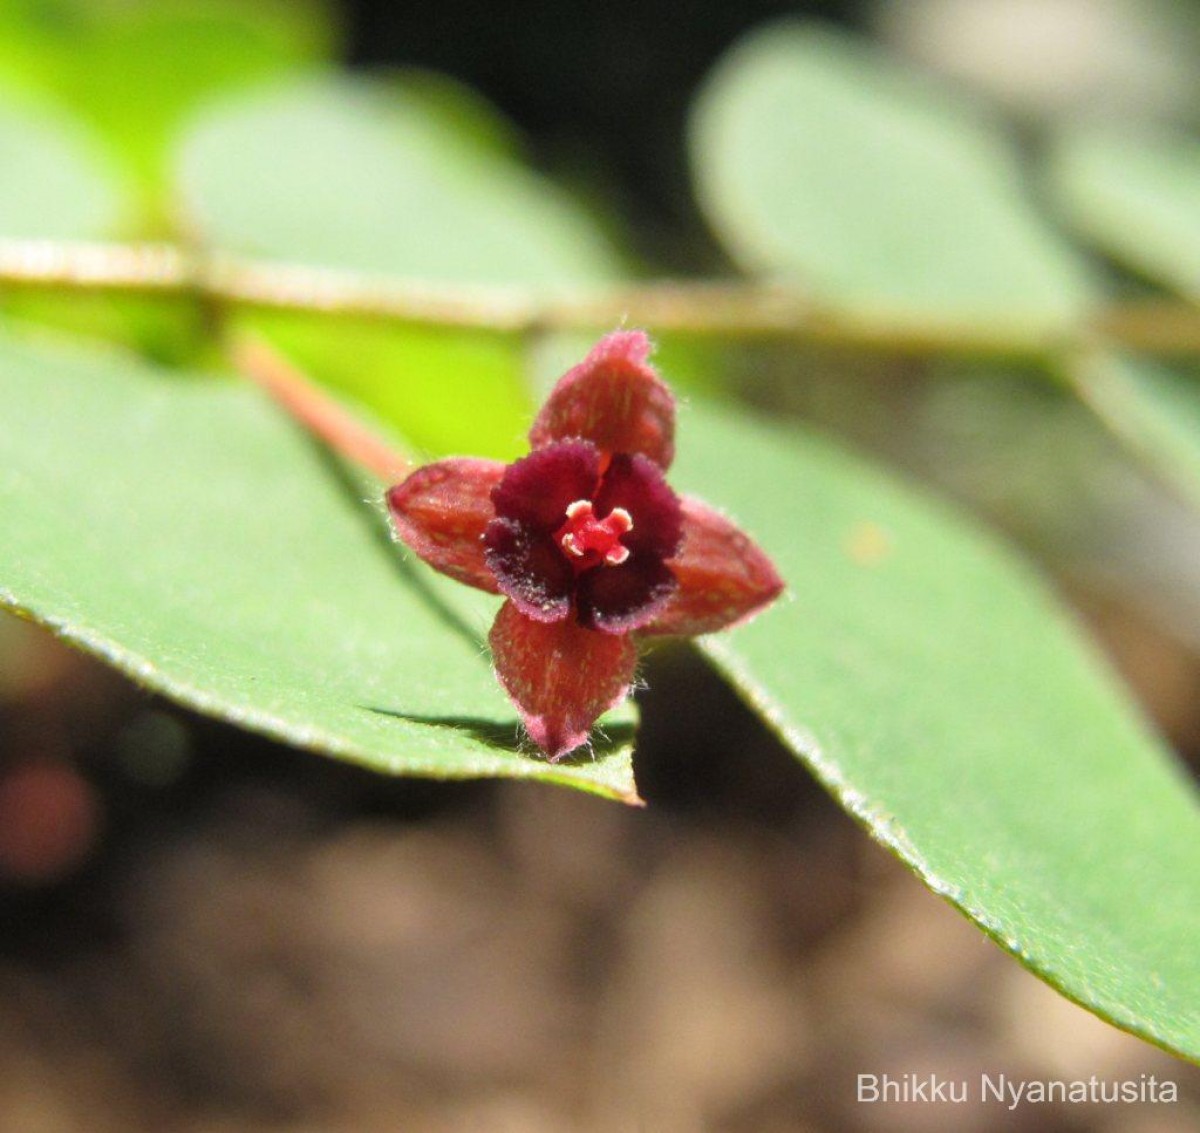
<box><xmin>488</xmin><ymin>601</ymin><xmax>637</xmax><ymax>762</ymax></box>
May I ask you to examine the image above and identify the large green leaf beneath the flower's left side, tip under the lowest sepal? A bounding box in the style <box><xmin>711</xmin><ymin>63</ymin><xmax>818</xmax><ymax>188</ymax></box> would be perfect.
<box><xmin>0</xmin><ymin>326</ymin><xmax>636</xmax><ymax>801</ymax></box>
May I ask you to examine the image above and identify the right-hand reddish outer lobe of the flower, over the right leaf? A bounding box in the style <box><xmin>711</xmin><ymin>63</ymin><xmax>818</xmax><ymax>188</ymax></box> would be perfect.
<box><xmin>642</xmin><ymin>496</ymin><xmax>784</xmax><ymax>636</ymax></box>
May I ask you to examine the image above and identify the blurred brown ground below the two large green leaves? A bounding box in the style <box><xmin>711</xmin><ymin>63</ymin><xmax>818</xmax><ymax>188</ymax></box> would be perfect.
<box><xmin>0</xmin><ymin>610</ymin><xmax>1200</xmax><ymax>1133</ymax></box>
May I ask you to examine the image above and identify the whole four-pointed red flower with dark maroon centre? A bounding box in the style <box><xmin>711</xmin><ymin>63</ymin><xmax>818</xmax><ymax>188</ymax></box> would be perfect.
<box><xmin>388</xmin><ymin>331</ymin><xmax>784</xmax><ymax>762</ymax></box>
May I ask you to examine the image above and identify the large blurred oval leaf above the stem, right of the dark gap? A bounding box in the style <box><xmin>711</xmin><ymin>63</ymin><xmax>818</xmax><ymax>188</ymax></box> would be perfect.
<box><xmin>691</xmin><ymin>22</ymin><xmax>1093</xmax><ymax>330</ymax></box>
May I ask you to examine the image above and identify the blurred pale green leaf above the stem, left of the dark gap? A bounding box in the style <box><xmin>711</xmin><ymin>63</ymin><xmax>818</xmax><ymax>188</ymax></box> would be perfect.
<box><xmin>178</xmin><ymin>79</ymin><xmax>617</xmax><ymax>290</ymax></box>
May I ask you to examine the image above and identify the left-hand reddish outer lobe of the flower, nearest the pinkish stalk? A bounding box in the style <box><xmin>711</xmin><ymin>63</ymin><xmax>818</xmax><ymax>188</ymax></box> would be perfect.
<box><xmin>388</xmin><ymin>457</ymin><xmax>504</xmax><ymax>594</ymax></box>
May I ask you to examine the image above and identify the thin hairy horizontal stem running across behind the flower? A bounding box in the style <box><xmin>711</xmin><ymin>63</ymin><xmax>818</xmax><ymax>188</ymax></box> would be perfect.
<box><xmin>0</xmin><ymin>240</ymin><xmax>1200</xmax><ymax>361</ymax></box>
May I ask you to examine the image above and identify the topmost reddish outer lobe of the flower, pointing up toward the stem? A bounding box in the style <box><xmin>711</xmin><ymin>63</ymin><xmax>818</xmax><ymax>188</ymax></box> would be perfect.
<box><xmin>529</xmin><ymin>330</ymin><xmax>674</xmax><ymax>468</ymax></box>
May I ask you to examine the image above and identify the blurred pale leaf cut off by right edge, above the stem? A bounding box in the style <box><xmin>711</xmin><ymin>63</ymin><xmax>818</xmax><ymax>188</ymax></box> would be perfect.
<box><xmin>1050</xmin><ymin>127</ymin><xmax>1200</xmax><ymax>299</ymax></box>
